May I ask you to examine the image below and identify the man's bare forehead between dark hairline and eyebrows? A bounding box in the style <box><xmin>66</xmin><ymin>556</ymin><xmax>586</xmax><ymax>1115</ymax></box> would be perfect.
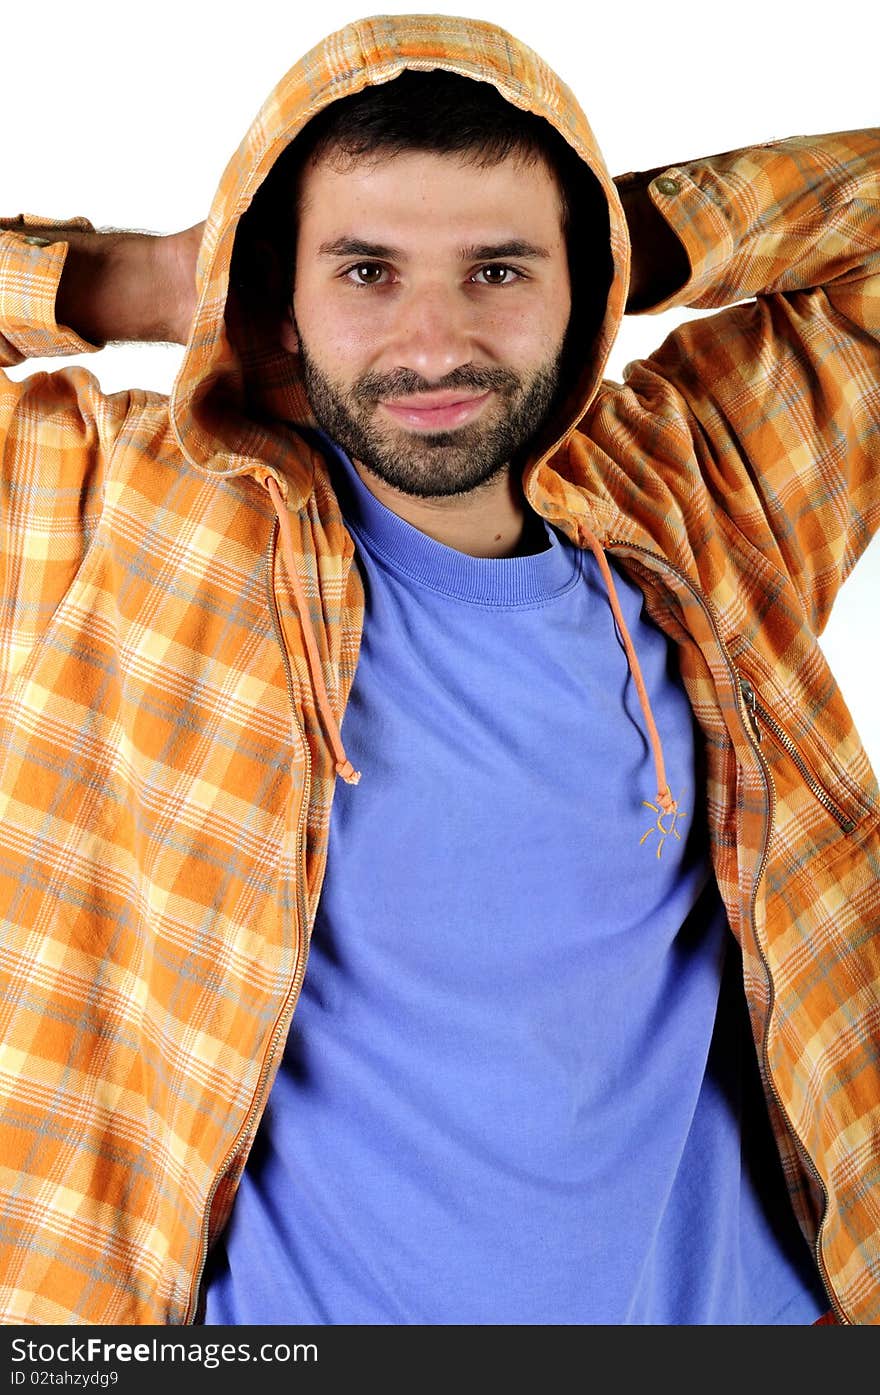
<box><xmin>298</xmin><ymin>151</ymin><xmax>562</xmax><ymax>241</ymax></box>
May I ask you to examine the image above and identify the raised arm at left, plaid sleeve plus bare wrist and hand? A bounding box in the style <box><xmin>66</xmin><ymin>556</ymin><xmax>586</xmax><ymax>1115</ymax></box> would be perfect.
<box><xmin>0</xmin><ymin>218</ymin><xmax>198</xmax><ymax>689</ymax></box>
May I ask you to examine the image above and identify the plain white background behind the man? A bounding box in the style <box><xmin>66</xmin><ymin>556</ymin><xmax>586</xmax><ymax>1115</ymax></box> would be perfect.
<box><xmin>6</xmin><ymin>0</ymin><xmax>880</xmax><ymax>769</ymax></box>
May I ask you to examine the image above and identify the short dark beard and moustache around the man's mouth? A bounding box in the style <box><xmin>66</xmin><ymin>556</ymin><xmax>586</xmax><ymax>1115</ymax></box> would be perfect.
<box><xmin>297</xmin><ymin>326</ymin><xmax>565</xmax><ymax>499</ymax></box>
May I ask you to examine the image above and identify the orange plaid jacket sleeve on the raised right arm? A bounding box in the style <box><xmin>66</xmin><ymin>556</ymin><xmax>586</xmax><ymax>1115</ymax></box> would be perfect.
<box><xmin>616</xmin><ymin>128</ymin><xmax>880</xmax><ymax>633</ymax></box>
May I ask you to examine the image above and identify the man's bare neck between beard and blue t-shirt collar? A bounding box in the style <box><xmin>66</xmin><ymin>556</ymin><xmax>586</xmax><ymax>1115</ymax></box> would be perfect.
<box><xmin>353</xmin><ymin>460</ymin><xmax>547</xmax><ymax>557</ymax></box>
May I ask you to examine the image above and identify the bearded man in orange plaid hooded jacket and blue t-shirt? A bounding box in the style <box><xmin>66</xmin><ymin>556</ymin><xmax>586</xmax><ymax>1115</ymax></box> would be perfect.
<box><xmin>0</xmin><ymin>15</ymin><xmax>880</xmax><ymax>1324</ymax></box>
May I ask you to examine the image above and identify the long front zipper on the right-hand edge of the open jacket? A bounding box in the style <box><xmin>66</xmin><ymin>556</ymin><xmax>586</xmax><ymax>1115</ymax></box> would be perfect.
<box><xmin>608</xmin><ymin>538</ymin><xmax>852</xmax><ymax>1327</ymax></box>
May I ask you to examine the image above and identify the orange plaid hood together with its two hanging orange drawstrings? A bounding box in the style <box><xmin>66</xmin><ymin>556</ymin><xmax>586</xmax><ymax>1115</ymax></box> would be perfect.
<box><xmin>170</xmin><ymin>14</ymin><xmax>675</xmax><ymax>813</ymax></box>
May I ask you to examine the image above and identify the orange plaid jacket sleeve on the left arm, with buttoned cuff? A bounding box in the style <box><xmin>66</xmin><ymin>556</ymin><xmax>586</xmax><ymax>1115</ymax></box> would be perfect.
<box><xmin>0</xmin><ymin>216</ymin><xmax>130</xmax><ymax>689</ymax></box>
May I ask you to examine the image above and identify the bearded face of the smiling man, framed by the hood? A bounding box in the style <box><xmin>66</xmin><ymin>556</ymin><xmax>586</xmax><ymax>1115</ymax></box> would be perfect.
<box><xmin>283</xmin><ymin>142</ymin><xmax>570</xmax><ymax>498</ymax></box>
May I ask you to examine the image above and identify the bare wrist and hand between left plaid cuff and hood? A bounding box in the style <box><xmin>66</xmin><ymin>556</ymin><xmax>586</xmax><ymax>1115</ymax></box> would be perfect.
<box><xmin>48</xmin><ymin>223</ymin><xmax>205</xmax><ymax>345</ymax></box>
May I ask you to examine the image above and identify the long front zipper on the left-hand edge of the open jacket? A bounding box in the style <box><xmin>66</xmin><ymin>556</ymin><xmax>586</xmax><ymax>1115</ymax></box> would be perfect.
<box><xmin>184</xmin><ymin>519</ymin><xmax>311</xmax><ymax>1324</ymax></box>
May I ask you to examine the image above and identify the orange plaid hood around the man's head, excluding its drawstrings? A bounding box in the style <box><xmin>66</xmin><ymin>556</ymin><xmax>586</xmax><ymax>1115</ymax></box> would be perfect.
<box><xmin>170</xmin><ymin>14</ymin><xmax>630</xmax><ymax>509</ymax></box>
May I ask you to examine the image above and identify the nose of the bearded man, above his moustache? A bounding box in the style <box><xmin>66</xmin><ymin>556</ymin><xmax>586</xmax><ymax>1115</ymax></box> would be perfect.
<box><xmin>393</xmin><ymin>285</ymin><xmax>474</xmax><ymax>382</ymax></box>
